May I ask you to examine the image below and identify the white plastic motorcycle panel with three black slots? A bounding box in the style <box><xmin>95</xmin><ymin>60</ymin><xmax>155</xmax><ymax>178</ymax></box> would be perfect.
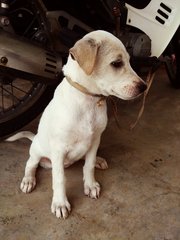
<box><xmin>126</xmin><ymin>0</ymin><xmax>180</xmax><ymax>57</ymax></box>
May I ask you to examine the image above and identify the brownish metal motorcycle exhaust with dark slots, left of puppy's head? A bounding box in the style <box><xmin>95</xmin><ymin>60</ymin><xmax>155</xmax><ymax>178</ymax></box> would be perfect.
<box><xmin>0</xmin><ymin>30</ymin><xmax>62</xmax><ymax>84</ymax></box>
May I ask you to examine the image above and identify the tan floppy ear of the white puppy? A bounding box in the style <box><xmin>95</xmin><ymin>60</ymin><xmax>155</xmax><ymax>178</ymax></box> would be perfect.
<box><xmin>69</xmin><ymin>39</ymin><xmax>99</xmax><ymax>75</ymax></box>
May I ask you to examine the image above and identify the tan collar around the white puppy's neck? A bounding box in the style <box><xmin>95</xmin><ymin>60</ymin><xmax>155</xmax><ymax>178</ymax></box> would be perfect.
<box><xmin>65</xmin><ymin>76</ymin><xmax>107</xmax><ymax>107</ymax></box>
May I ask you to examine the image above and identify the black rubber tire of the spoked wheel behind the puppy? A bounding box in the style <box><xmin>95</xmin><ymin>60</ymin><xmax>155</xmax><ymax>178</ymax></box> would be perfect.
<box><xmin>0</xmin><ymin>83</ymin><xmax>55</xmax><ymax>139</ymax></box>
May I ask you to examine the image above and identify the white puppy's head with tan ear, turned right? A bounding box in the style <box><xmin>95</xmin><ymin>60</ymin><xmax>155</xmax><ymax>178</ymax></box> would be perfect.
<box><xmin>65</xmin><ymin>30</ymin><xmax>146</xmax><ymax>100</ymax></box>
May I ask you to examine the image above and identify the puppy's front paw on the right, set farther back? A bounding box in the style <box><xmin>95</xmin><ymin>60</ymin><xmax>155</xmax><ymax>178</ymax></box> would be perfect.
<box><xmin>84</xmin><ymin>182</ymin><xmax>101</xmax><ymax>199</ymax></box>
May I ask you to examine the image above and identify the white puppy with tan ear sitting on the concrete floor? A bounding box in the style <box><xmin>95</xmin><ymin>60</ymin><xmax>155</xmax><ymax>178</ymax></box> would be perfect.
<box><xmin>9</xmin><ymin>30</ymin><xmax>146</xmax><ymax>218</ymax></box>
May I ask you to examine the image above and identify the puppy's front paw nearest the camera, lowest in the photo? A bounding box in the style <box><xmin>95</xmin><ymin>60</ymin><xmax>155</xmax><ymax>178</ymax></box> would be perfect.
<box><xmin>51</xmin><ymin>200</ymin><xmax>71</xmax><ymax>219</ymax></box>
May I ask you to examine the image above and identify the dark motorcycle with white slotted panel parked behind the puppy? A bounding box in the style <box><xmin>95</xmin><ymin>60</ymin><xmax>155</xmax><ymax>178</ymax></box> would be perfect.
<box><xmin>0</xmin><ymin>0</ymin><xmax>180</xmax><ymax>138</ymax></box>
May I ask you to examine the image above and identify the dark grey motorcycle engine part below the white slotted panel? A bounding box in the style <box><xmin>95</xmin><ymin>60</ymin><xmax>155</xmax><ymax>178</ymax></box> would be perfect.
<box><xmin>120</xmin><ymin>32</ymin><xmax>151</xmax><ymax>57</ymax></box>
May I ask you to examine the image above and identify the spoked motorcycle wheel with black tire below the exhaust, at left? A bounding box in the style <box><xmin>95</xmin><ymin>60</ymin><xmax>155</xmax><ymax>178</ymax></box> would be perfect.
<box><xmin>0</xmin><ymin>76</ymin><xmax>55</xmax><ymax>138</ymax></box>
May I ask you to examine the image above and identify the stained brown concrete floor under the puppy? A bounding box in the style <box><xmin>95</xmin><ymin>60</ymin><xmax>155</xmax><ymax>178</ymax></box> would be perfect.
<box><xmin>0</xmin><ymin>65</ymin><xmax>180</xmax><ymax>240</ymax></box>
